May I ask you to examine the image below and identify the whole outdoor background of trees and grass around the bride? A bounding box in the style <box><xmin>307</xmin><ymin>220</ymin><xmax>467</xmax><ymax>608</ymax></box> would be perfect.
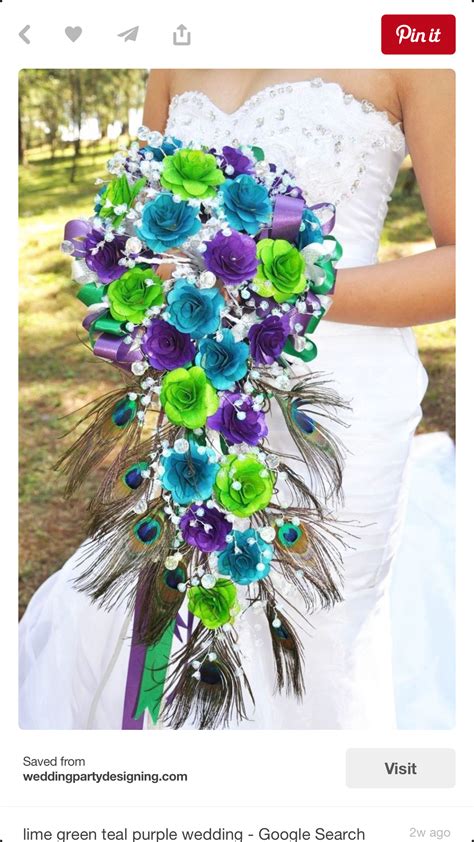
<box><xmin>19</xmin><ymin>70</ymin><xmax>455</xmax><ymax>609</ymax></box>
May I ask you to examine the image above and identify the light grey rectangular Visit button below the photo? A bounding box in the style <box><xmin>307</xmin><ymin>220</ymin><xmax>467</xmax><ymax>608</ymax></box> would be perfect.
<box><xmin>346</xmin><ymin>748</ymin><xmax>456</xmax><ymax>789</ymax></box>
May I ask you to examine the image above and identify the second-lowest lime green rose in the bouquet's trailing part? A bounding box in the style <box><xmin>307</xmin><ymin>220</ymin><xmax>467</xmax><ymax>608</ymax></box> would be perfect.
<box><xmin>214</xmin><ymin>454</ymin><xmax>275</xmax><ymax>517</ymax></box>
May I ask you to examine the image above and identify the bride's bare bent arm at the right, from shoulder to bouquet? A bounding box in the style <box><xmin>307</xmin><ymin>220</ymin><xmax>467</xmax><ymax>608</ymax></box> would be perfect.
<box><xmin>328</xmin><ymin>70</ymin><xmax>455</xmax><ymax>327</ymax></box>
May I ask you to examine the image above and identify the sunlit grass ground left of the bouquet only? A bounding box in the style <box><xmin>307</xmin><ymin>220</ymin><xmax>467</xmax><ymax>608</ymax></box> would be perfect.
<box><xmin>19</xmin><ymin>146</ymin><xmax>120</xmax><ymax>609</ymax></box>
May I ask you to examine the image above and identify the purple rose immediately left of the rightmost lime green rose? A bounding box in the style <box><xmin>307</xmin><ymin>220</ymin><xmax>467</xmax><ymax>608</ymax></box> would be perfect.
<box><xmin>204</xmin><ymin>231</ymin><xmax>258</xmax><ymax>284</ymax></box>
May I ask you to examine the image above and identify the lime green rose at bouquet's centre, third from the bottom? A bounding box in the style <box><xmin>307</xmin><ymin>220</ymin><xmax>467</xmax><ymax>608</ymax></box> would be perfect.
<box><xmin>160</xmin><ymin>365</ymin><xmax>219</xmax><ymax>430</ymax></box>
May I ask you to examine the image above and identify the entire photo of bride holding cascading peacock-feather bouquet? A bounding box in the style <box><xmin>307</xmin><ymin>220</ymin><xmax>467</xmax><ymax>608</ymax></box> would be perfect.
<box><xmin>19</xmin><ymin>69</ymin><xmax>455</xmax><ymax>730</ymax></box>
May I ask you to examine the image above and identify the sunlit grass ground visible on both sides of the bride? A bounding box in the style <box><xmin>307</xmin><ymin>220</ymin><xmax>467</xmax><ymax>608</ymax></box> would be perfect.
<box><xmin>19</xmin><ymin>144</ymin><xmax>455</xmax><ymax>610</ymax></box>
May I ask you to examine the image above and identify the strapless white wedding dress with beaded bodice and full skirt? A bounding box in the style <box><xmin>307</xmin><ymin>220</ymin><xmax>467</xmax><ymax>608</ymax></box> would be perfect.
<box><xmin>20</xmin><ymin>79</ymin><xmax>436</xmax><ymax>729</ymax></box>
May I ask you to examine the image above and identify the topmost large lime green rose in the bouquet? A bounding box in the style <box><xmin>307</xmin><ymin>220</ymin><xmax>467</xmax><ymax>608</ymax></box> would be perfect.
<box><xmin>161</xmin><ymin>149</ymin><xmax>225</xmax><ymax>199</ymax></box>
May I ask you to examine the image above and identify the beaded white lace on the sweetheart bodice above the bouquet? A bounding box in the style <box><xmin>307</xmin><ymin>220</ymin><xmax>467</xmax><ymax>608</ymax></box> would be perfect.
<box><xmin>166</xmin><ymin>78</ymin><xmax>405</xmax><ymax>205</ymax></box>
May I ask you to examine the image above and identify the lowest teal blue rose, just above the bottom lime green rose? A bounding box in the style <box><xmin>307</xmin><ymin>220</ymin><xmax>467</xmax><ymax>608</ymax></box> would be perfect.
<box><xmin>217</xmin><ymin>529</ymin><xmax>273</xmax><ymax>585</ymax></box>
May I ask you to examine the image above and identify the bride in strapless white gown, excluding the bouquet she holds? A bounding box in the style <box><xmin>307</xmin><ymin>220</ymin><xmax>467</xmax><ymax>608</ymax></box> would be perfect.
<box><xmin>20</xmin><ymin>70</ymin><xmax>455</xmax><ymax>729</ymax></box>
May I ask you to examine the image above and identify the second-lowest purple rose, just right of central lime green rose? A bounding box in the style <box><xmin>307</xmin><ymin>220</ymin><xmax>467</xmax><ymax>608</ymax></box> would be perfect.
<box><xmin>207</xmin><ymin>392</ymin><xmax>268</xmax><ymax>445</ymax></box>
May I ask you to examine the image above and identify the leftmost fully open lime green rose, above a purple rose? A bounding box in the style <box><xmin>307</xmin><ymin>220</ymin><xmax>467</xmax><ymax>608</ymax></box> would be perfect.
<box><xmin>107</xmin><ymin>266</ymin><xmax>164</xmax><ymax>325</ymax></box>
